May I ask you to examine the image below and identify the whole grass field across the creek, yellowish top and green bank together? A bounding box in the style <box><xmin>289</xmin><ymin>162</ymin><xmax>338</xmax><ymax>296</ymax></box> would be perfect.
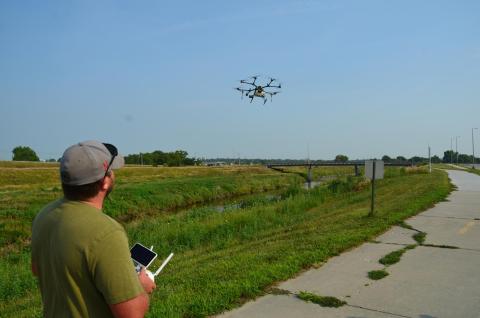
<box><xmin>0</xmin><ymin>166</ymin><xmax>302</xmax><ymax>256</ymax></box>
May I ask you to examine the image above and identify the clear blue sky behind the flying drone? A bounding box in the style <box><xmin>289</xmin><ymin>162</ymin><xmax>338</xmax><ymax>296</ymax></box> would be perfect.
<box><xmin>0</xmin><ymin>0</ymin><xmax>480</xmax><ymax>160</ymax></box>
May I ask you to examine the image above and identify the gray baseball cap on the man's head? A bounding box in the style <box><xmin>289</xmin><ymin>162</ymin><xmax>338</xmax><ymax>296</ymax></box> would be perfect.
<box><xmin>60</xmin><ymin>140</ymin><xmax>125</xmax><ymax>186</ymax></box>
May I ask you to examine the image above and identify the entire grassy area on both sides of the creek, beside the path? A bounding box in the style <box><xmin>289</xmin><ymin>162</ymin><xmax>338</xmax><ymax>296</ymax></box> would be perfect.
<box><xmin>0</xmin><ymin>167</ymin><xmax>451</xmax><ymax>317</ymax></box>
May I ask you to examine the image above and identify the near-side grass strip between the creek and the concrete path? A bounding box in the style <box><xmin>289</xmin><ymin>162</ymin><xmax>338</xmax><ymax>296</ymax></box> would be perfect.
<box><xmin>0</xmin><ymin>171</ymin><xmax>451</xmax><ymax>317</ymax></box>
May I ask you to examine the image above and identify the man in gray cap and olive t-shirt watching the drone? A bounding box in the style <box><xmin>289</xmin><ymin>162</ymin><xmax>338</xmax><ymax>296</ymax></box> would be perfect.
<box><xmin>32</xmin><ymin>141</ymin><xmax>156</xmax><ymax>317</ymax></box>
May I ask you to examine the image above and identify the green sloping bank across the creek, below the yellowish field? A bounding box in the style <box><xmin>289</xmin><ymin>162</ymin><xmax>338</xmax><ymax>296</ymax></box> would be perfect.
<box><xmin>0</xmin><ymin>173</ymin><xmax>302</xmax><ymax>255</ymax></box>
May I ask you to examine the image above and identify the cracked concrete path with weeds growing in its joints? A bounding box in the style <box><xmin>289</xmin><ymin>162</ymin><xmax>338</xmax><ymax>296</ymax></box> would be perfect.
<box><xmin>220</xmin><ymin>171</ymin><xmax>480</xmax><ymax>318</ymax></box>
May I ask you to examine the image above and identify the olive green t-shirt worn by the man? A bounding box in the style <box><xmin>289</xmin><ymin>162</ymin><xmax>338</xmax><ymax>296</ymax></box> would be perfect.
<box><xmin>32</xmin><ymin>199</ymin><xmax>144</xmax><ymax>317</ymax></box>
